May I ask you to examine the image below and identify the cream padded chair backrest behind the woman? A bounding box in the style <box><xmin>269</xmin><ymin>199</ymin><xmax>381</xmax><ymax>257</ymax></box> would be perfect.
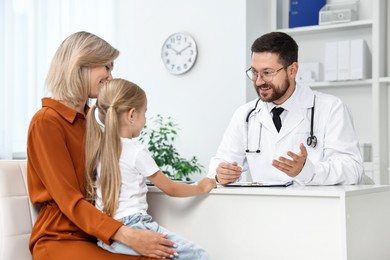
<box><xmin>0</xmin><ymin>160</ymin><xmax>39</xmax><ymax>260</ymax></box>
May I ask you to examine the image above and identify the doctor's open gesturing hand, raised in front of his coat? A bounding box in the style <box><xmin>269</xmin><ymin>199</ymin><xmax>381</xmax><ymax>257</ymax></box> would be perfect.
<box><xmin>272</xmin><ymin>143</ymin><xmax>307</xmax><ymax>177</ymax></box>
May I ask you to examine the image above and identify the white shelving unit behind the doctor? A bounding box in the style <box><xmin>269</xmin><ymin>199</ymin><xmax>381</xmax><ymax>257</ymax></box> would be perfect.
<box><xmin>268</xmin><ymin>0</ymin><xmax>390</xmax><ymax>184</ymax></box>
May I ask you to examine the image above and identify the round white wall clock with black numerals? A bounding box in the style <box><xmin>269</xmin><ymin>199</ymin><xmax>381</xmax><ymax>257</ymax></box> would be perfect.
<box><xmin>161</xmin><ymin>33</ymin><xmax>197</xmax><ymax>74</ymax></box>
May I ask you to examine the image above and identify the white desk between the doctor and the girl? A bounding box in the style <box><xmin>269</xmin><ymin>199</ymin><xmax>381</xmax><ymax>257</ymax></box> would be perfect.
<box><xmin>148</xmin><ymin>185</ymin><xmax>390</xmax><ymax>260</ymax></box>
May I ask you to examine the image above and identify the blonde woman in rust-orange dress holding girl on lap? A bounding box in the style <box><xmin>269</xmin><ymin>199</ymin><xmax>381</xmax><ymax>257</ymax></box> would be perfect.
<box><xmin>27</xmin><ymin>32</ymin><xmax>175</xmax><ymax>260</ymax></box>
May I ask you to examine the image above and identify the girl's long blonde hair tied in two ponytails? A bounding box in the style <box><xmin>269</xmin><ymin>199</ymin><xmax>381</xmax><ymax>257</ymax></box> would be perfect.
<box><xmin>85</xmin><ymin>79</ymin><xmax>146</xmax><ymax>216</ymax></box>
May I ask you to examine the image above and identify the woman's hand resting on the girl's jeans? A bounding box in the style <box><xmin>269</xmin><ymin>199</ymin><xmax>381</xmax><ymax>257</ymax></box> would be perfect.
<box><xmin>112</xmin><ymin>226</ymin><xmax>178</xmax><ymax>258</ymax></box>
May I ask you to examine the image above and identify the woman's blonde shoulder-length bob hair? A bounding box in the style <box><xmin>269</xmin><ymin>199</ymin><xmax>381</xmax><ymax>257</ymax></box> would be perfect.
<box><xmin>46</xmin><ymin>32</ymin><xmax>119</xmax><ymax>104</ymax></box>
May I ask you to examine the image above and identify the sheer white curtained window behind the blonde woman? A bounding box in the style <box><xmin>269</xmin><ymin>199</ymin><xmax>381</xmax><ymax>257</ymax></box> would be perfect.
<box><xmin>0</xmin><ymin>0</ymin><xmax>119</xmax><ymax>159</ymax></box>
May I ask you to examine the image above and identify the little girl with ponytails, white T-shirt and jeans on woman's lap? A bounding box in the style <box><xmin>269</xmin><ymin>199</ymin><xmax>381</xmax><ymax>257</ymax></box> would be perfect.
<box><xmin>85</xmin><ymin>79</ymin><xmax>216</xmax><ymax>260</ymax></box>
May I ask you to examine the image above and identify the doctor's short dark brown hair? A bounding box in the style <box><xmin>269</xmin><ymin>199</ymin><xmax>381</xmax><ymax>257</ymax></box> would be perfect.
<box><xmin>251</xmin><ymin>32</ymin><xmax>298</xmax><ymax>67</ymax></box>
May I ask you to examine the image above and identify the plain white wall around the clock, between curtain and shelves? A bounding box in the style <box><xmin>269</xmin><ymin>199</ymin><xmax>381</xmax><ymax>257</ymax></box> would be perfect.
<box><xmin>113</xmin><ymin>0</ymin><xmax>267</xmax><ymax>178</ymax></box>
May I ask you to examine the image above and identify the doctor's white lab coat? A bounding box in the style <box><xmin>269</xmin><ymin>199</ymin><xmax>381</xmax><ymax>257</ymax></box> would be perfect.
<box><xmin>208</xmin><ymin>85</ymin><xmax>363</xmax><ymax>185</ymax></box>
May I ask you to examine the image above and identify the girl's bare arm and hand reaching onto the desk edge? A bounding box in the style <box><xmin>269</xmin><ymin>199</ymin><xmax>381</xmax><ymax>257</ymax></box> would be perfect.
<box><xmin>148</xmin><ymin>171</ymin><xmax>217</xmax><ymax>197</ymax></box>
